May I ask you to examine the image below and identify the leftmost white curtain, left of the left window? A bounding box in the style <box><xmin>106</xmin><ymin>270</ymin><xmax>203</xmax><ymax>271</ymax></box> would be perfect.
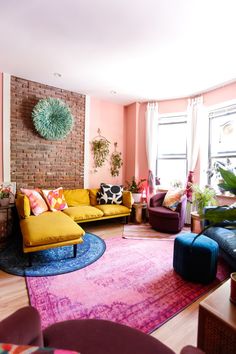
<box><xmin>145</xmin><ymin>103</ymin><xmax>158</xmax><ymax>194</ymax></box>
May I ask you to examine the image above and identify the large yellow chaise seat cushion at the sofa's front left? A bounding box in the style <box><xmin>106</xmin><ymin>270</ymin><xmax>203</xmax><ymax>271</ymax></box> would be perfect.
<box><xmin>20</xmin><ymin>211</ymin><xmax>84</xmax><ymax>246</ymax></box>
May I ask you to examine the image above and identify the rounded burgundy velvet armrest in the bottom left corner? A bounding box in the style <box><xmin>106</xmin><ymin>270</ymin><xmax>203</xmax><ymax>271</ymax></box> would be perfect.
<box><xmin>0</xmin><ymin>306</ymin><xmax>43</xmax><ymax>347</ymax></box>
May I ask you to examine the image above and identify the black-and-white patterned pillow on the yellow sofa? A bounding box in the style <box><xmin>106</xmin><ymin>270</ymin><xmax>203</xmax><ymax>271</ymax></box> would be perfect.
<box><xmin>97</xmin><ymin>183</ymin><xmax>123</xmax><ymax>204</ymax></box>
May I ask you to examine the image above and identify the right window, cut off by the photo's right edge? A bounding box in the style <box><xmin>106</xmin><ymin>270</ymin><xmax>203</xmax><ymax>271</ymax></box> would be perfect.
<box><xmin>208</xmin><ymin>105</ymin><xmax>236</xmax><ymax>191</ymax></box>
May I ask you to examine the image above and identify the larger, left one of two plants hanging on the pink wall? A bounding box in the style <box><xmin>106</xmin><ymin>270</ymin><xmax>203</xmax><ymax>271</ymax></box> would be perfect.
<box><xmin>91</xmin><ymin>129</ymin><xmax>110</xmax><ymax>168</ymax></box>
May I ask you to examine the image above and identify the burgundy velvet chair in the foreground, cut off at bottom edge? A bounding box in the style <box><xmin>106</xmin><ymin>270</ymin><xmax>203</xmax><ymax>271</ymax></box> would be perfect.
<box><xmin>0</xmin><ymin>306</ymin><xmax>204</xmax><ymax>354</ymax></box>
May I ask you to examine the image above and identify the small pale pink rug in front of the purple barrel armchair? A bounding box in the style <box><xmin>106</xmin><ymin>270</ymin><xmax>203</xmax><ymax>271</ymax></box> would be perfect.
<box><xmin>122</xmin><ymin>223</ymin><xmax>190</xmax><ymax>240</ymax></box>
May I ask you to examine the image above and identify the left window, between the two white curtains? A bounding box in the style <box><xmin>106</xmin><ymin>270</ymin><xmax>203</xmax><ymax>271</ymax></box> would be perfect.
<box><xmin>156</xmin><ymin>114</ymin><xmax>187</xmax><ymax>187</ymax></box>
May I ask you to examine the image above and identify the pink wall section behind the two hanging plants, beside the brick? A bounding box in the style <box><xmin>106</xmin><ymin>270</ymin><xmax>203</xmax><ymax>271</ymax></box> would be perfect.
<box><xmin>89</xmin><ymin>97</ymin><xmax>125</xmax><ymax>188</ymax></box>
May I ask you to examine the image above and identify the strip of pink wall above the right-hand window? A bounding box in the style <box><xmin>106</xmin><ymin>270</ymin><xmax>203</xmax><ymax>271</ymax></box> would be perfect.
<box><xmin>203</xmin><ymin>82</ymin><xmax>236</xmax><ymax>106</ymax></box>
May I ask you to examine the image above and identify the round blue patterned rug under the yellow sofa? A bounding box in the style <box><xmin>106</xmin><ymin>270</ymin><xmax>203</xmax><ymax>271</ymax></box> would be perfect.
<box><xmin>0</xmin><ymin>233</ymin><xmax>106</xmax><ymax>277</ymax></box>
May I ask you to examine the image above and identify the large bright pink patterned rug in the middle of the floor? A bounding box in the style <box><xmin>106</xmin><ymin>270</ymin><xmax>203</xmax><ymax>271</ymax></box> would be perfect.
<box><xmin>26</xmin><ymin>238</ymin><xmax>229</xmax><ymax>333</ymax></box>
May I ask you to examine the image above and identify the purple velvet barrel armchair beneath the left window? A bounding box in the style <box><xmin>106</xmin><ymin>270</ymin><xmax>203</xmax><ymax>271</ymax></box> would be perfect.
<box><xmin>148</xmin><ymin>192</ymin><xmax>187</xmax><ymax>233</ymax></box>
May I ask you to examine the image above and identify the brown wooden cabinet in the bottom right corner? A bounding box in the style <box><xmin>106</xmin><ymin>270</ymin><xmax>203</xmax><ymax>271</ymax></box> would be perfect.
<box><xmin>198</xmin><ymin>280</ymin><xmax>236</xmax><ymax>354</ymax></box>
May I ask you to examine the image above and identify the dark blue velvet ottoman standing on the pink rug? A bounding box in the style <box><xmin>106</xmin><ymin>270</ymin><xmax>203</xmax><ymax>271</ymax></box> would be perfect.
<box><xmin>173</xmin><ymin>233</ymin><xmax>219</xmax><ymax>284</ymax></box>
